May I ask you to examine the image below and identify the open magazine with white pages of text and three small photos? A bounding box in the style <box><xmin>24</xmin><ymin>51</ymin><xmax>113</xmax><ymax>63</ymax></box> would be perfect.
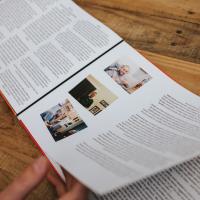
<box><xmin>0</xmin><ymin>0</ymin><xmax>200</xmax><ymax>200</ymax></box>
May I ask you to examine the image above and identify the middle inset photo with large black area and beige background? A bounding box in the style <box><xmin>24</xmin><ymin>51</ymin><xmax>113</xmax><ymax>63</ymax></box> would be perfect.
<box><xmin>69</xmin><ymin>75</ymin><xmax>117</xmax><ymax>115</ymax></box>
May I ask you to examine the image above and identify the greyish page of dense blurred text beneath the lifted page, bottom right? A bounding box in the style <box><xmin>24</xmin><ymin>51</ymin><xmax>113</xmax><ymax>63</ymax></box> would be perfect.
<box><xmin>89</xmin><ymin>157</ymin><xmax>200</xmax><ymax>200</ymax></box>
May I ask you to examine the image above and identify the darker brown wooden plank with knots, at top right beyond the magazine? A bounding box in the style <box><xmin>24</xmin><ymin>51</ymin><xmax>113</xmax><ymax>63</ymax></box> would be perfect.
<box><xmin>75</xmin><ymin>0</ymin><xmax>200</xmax><ymax>63</ymax></box>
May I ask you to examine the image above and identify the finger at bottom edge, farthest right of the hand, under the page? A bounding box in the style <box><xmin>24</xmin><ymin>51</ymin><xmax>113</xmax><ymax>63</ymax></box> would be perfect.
<box><xmin>60</xmin><ymin>182</ymin><xmax>88</xmax><ymax>200</ymax></box>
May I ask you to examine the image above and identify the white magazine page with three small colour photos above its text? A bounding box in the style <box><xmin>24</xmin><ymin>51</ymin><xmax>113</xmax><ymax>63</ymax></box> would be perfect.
<box><xmin>19</xmin><ymin>42</ymin><xmax>200</xmax><ymax>194</ymax></box>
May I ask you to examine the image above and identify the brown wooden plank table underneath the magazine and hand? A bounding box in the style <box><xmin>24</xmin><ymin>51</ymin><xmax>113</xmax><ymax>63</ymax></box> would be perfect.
<box><xmin>0</xmin><ymin>0</ymin><xmax>200</xmax><ymax>199</ymax></box>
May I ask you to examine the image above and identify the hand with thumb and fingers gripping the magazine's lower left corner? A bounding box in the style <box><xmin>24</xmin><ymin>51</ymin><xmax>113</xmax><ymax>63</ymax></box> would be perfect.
<box><xmin>0</xmin><ymin>157</ymin><xmax>87</xmax><ymax>200</ymax></box>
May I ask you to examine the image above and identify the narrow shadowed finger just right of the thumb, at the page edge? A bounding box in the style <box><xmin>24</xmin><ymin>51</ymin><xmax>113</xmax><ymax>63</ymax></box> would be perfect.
<box><xmin>47</xmin><ymin>172</ymin><xmax>67</xmax><ymax>197</ymax></box>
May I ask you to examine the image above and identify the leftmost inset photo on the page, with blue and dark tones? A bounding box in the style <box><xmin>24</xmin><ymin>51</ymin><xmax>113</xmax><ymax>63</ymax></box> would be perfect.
<box><xmin>41</xmin><ymin>99</ymin><xmax>87</xmax><ymax>142</ymax></box>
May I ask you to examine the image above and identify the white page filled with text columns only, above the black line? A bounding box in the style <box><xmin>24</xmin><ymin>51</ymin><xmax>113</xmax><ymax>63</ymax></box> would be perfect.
<box><xmin>0</xmin><ymin>0</ymin><xmax>121</xmax><ymax>114</ymax></box>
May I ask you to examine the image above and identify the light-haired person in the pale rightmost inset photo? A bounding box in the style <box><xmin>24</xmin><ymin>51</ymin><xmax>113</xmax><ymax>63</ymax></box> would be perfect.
<box><xmin>105</xmin><ymin>63</ymin><xmax>130</xmax><ymax>88</ymax></box>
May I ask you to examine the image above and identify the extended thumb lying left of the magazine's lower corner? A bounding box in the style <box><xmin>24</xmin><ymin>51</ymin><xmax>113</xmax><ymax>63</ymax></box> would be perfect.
<box><xmin>0</xmin><ymin>157</ymin><xmax>49</xmax><ymax>200</ymax></box>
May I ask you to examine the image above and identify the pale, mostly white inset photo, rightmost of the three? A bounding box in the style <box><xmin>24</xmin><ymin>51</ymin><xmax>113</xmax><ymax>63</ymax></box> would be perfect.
<box><xmin>105</xmin><ymin>58</ymin><xmax>152</xmax><ymax>94</ymax></box>
